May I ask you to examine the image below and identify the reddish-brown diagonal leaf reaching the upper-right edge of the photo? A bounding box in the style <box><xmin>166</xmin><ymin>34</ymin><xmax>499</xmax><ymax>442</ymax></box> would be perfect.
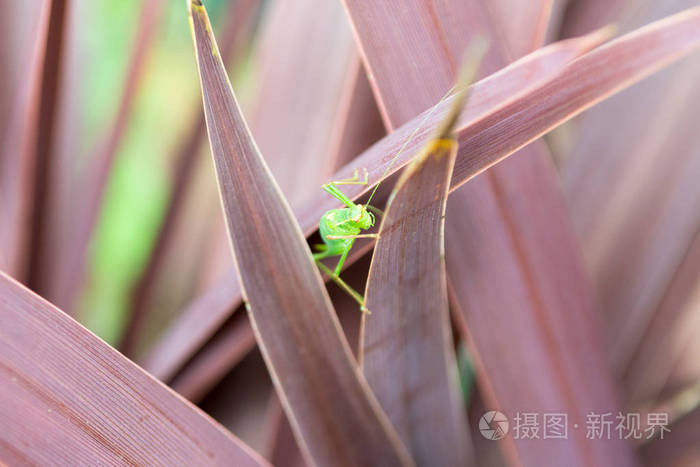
<box><xmin>452</xmin><ymin>7</ymin><xmax>700</xmax><ymax>190</ymax></box>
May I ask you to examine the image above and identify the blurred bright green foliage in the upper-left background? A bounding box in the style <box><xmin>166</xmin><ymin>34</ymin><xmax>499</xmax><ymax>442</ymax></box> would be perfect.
<box><xmin>73</xmin><ymin>0</ymin><xmax>227</xmax><ymax>343</ymax></box>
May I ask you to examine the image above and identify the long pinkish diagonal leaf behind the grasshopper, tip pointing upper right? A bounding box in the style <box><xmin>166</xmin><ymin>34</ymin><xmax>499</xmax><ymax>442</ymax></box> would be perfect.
<box><xmin>140</xmin><ymin>27</ymin><xmax>607</xmax><ymax>380</ymax></box>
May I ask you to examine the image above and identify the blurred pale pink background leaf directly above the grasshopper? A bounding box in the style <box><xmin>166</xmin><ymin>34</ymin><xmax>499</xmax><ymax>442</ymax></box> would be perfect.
<box><xmin>250</xmin><ymin>0</ymin><xmax>357</xmax><ymax>206</ymax></box>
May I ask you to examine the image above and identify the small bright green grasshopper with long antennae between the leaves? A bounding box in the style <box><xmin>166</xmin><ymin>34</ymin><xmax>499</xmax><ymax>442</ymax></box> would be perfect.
<box><xmin>313</xmin><ymin>43</ymin><xmax>485</xmax><ymax>313</ymax></box>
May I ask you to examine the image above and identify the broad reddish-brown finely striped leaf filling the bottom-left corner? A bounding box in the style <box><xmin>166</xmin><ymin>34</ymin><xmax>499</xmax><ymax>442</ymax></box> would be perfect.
<box><xmin>0</xmin><ymin>273</ymin><xmax>268</xmax><ymax>466</ymax></box>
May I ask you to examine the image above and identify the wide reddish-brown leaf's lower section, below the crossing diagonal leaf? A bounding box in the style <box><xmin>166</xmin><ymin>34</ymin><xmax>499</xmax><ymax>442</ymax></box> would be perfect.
<box><xmin>445</xmin><ymin>0</ymin><xmax>633</xmax><ymax>465</ymax></box>
